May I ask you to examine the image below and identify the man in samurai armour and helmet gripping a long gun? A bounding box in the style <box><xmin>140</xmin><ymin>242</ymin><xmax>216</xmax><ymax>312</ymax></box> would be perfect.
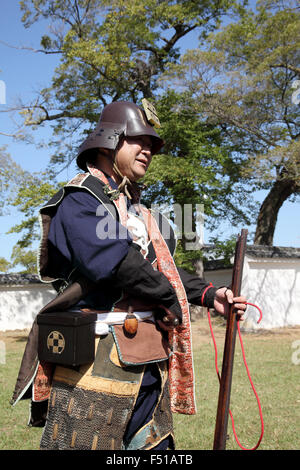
<box><xmin>11</xmin><ymin>101</ymin><xmax>246</xmax><ymax>450</ymax></box>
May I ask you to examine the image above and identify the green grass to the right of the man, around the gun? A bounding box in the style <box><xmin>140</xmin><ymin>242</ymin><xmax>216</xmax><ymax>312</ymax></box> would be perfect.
<box><xmin>174</xmin><ymin>320</ymin><xmax>300</xmax><ymax>450</ymax></box>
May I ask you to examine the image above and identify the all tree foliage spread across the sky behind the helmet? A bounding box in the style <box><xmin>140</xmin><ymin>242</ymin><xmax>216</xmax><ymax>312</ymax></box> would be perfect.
<box><xmin>3</xmin><ymin>0</ymin><xmax>299</xmax><ymax>258</ymax></box>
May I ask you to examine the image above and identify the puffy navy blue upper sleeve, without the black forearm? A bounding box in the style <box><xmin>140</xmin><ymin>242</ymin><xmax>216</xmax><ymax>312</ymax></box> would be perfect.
<box><xmin>48</xmin><ymin>191</ymin><xmax>132</xmax><ymax>282</ymax></box>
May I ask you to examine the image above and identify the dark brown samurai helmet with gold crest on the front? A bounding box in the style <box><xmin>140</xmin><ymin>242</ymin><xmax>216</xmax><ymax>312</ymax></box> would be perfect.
<box><xmin>76</xmin><ymin>99</ymin><xmax>164</xmax><ymax>171</ymax></box>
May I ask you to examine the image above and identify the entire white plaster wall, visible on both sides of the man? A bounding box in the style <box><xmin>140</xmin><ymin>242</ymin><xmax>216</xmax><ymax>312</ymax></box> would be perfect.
<box><xmin>0</xmin><ymin>256</ymin><xmax>300</xmax><ymax>331</ymax></box>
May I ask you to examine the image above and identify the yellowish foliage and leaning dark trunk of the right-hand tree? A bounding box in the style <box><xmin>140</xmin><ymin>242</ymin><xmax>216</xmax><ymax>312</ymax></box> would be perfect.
<box><xmin>164</xmin><ymin>0</ymin><xmax>300</xmax><ymax>244</ymax></box>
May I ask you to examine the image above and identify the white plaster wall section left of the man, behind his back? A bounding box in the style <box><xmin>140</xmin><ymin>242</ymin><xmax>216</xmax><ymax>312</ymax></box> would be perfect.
<box><xmin>0</xmin><ymin>284</ymin><xmax>56</xmax><ymax>331</ymax></box>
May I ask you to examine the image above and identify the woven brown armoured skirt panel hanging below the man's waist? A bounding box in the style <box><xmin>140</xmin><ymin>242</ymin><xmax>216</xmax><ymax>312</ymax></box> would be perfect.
<box><xmin>40</xmin><ymin>334</ymin><xmax>173</xmax><ymax>450</ymax></box>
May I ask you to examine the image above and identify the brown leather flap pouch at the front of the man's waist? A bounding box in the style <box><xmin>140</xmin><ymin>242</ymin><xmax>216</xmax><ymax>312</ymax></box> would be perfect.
<box><xmin>111</xmin><ymin>320</ymin><xmax>171</xmax><ymax>365</ymax></box>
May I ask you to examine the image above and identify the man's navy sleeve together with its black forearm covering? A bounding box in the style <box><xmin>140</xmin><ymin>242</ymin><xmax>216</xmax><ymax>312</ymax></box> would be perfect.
<box><xmin>49</xmin><ymin>191</ymin><xmax>182</xmax><ymax>319</ymax></box>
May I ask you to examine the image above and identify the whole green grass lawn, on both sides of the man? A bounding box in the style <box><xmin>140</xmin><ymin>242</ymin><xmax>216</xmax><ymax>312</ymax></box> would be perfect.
<box><xmin>0</xmin><ymin>319</ymin><xmax>300</xmax><ymax>450</ymax></box>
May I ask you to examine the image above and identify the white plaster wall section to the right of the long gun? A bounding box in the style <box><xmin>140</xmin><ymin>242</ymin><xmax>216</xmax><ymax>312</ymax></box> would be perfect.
<box><xmin>241</xmin><ymin>256</ymin><xmax>300</xmax><ymax>329</ymax></box>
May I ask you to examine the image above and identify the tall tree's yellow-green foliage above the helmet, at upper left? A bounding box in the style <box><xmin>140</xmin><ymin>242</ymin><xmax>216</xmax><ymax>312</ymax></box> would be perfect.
<box><xmin>14</xmin><ymin>0</ymin><xmax>241</xmax><ymax>173</ymax></box>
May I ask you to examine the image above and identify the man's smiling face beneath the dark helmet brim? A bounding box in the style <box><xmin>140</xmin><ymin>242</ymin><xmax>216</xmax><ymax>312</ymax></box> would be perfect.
<box><xmin>116</xmin><ymin>135</ymin><xmax>152</xmax><ymax>181</ymax></box>
